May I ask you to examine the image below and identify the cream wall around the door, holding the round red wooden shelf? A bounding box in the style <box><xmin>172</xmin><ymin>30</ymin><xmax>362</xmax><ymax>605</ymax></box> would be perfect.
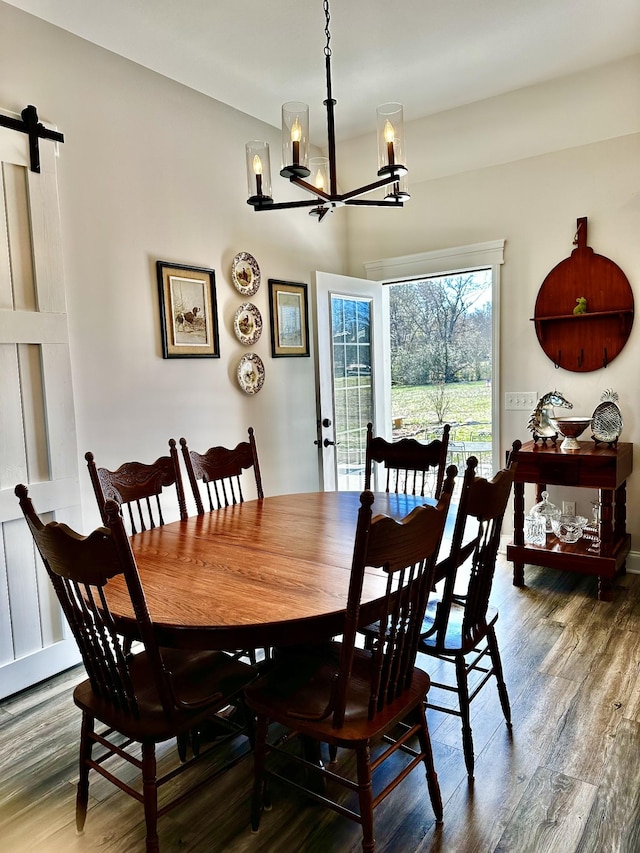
<box><xmin>346</xmin><ymin>56</ymin><xmax>640</xmax><ymax>551</ymax></box>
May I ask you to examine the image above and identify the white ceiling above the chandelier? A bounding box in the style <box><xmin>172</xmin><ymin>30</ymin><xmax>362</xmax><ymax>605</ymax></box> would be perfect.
<box><xmin>7</xmin><ymin>0</ymin><xmax>640</xmax><ymax>144</ymax></box>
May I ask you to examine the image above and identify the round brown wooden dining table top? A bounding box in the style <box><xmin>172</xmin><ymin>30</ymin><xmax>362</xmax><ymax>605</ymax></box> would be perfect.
<box><xmin>108</xmin><ymin>492</ymin><xmax>431</xmax><ymax>649</ymax></box>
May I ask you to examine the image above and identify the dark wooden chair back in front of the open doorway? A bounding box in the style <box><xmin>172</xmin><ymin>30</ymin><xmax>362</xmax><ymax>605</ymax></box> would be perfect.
<box><xmin>364</xmin><ymin>423</ymin><xmax>451</xmax><ymax>499</ymax></box>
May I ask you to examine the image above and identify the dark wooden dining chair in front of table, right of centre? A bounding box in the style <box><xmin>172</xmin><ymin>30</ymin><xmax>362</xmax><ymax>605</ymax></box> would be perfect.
<box><xmin>245</xmin><ymin>469</ymin><xmax>455</xmax><ymax>853</ymax></box>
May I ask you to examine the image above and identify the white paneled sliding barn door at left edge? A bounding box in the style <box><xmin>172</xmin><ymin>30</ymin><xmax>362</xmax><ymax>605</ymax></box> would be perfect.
<box><xmin>0</xmin><ymin>116</ymin><xmax>81</xmax><ymax>698</ymax></box>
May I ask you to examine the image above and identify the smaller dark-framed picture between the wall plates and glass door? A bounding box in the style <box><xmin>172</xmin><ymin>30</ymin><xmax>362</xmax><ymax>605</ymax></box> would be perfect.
<box><xmin>269</xmin><ymin>278</ymin><xmax>309</xmax><ymax>358</ymax></box>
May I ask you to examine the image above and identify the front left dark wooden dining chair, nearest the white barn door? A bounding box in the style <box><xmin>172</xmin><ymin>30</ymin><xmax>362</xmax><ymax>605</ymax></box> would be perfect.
<box><xmin>15</xmin><ymin>486</ymin><xmax>255</xmax><ymax>853</ymax></box>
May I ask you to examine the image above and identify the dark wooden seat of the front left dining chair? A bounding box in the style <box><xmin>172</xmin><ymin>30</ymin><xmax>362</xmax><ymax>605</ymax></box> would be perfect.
<box><xmin>73</xmin><ymin>649</ymin><xmax>255</xmax><ymax>743</ymax></box>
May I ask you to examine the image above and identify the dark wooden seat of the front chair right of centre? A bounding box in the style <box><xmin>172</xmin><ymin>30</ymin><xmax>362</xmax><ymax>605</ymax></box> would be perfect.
<box><xmin>245</xmin><ymin>643</ymin><xmax>430</xmax><ymax>747</ymax></box>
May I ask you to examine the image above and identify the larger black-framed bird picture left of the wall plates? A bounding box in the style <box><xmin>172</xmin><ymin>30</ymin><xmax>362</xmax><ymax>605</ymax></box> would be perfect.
<box><xmin>156</xmin><ymin>261</ymin><xmax>220</xmax><ymax>358</ymax></box>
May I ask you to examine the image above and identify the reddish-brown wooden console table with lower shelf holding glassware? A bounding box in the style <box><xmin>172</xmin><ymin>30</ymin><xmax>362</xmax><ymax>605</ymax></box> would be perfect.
<box><xmin>507</xmin><ymin>441</ymin><xmax>633</xmax><ymax>601</ymax></box>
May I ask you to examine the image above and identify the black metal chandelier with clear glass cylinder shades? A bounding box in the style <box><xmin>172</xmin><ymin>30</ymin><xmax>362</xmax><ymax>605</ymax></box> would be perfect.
<box><xmin>246</xmin><ymin>0</ymin><xmax>411</xmax><ymax>221</ymax></box>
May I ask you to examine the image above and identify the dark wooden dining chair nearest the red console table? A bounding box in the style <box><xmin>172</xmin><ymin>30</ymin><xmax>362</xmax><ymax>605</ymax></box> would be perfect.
<box><xmin>418</xmin><ymin>441</ymin><xmax>521</xmax><ymax>779</ymax></box>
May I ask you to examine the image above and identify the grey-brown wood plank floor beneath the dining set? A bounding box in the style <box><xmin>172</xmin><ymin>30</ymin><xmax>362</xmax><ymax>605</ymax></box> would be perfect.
<box><xmin>0</xmin><ymin>559</ymin><xmax>640</xmax><ymax>853</ymax></box>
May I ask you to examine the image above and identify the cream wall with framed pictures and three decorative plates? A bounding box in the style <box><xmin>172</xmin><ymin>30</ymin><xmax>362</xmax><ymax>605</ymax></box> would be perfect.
<box><xmin>0</xmin><ymin>2</ymin><xmax>345</xmax><ymax>526</ymax></box>
